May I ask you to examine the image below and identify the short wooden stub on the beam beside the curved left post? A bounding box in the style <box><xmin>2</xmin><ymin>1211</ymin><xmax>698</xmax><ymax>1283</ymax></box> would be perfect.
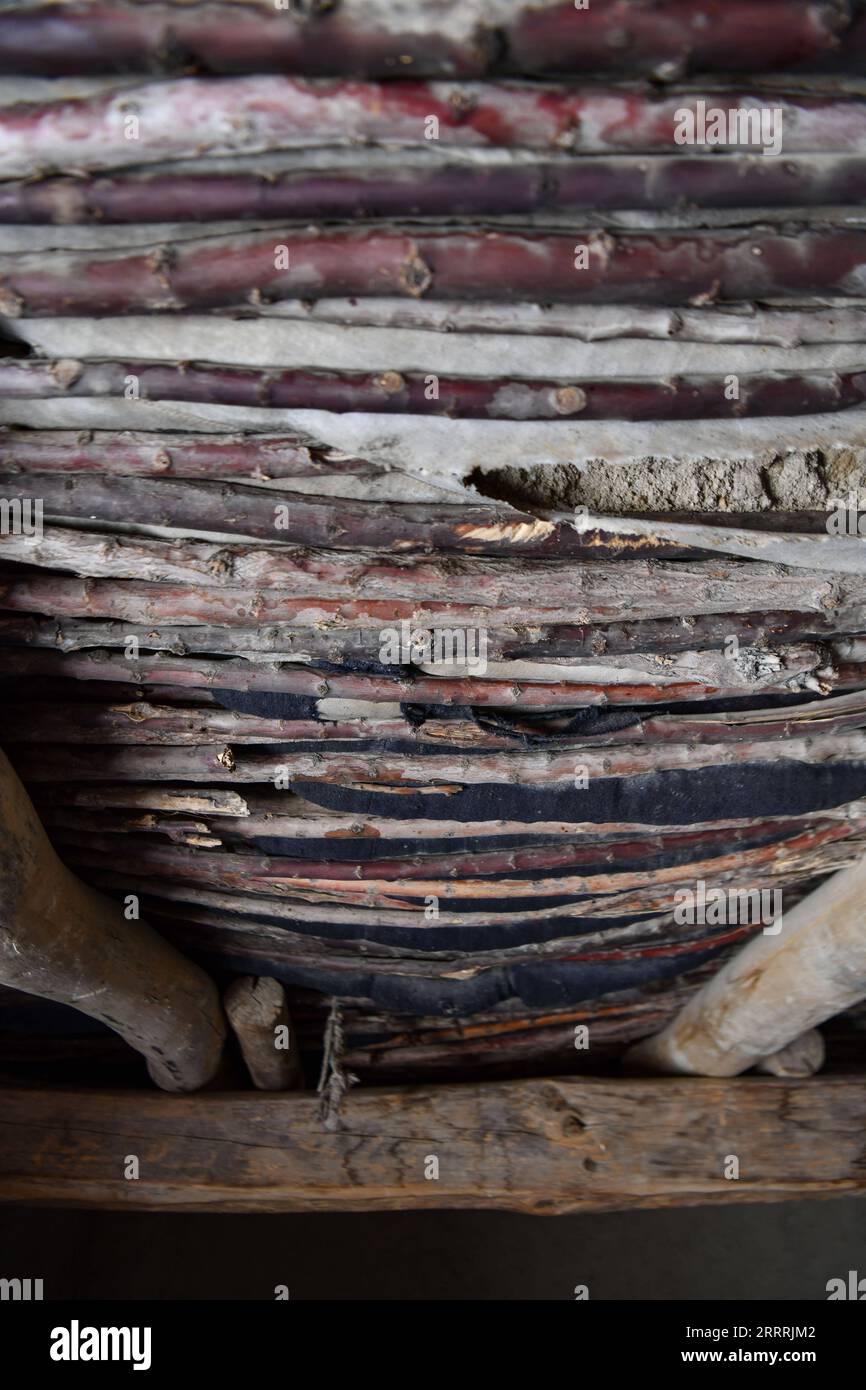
<box><xmin>224</xmin><ymin>976</ymin><xmax>303</xmax><ymax>1091</ymax></box>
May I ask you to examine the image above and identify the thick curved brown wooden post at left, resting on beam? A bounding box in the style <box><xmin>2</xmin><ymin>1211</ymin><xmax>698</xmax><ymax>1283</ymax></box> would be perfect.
<box><xmin>0</xmin><ymin>753</ymin><xmax>225</xmax><ymax>1091</ymax></box>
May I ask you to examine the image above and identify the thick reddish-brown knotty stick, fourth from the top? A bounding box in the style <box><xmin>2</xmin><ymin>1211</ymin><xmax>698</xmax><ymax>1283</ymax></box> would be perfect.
<box><xmin>0</xmin><ymin>228</ymin><xmax>866</xmax><ymax>317</ymax></box>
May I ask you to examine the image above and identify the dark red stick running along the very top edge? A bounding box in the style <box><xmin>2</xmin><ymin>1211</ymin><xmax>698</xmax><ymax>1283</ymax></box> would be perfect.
<box><xmin>0</xmin><ymin>0</ymin><xmax>866</xmax><ymax>81</ymax></box>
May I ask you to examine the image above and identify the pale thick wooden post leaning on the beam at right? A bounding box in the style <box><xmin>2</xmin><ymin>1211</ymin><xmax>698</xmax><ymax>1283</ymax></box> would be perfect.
<box><xmin>626</xmin><ymin>859</ymin><xmax>866</xmax><ymax>1076</ymax></box>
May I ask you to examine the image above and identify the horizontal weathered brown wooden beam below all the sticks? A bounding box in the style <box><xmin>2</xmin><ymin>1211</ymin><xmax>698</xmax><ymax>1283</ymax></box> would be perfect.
<box><xmin>0</xmin><ymin>1076</ymin><xmax>866</xmax><ymax>1213</ymax></box>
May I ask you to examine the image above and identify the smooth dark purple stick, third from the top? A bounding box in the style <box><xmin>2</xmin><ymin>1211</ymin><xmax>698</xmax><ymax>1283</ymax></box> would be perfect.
<box><xmin>0</xmin><ymin>154</ymin><xmax>866</xmax><ymax>227</ymax></box>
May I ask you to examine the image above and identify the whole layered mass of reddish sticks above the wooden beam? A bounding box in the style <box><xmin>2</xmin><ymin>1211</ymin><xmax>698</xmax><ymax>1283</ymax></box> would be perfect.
<box><xmin>0</xmin><ymin>0</ymin><xmax>866</xmax><ymax>1077</ymax></box>
